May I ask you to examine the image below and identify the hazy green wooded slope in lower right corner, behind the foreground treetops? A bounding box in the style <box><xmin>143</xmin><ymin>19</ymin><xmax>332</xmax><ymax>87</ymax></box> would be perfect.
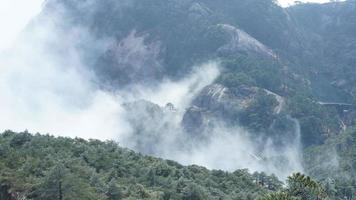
<box><xmin>304</xmin><ymin>127</ymin><xmax>356</xmax><ymax>200</ymax></box>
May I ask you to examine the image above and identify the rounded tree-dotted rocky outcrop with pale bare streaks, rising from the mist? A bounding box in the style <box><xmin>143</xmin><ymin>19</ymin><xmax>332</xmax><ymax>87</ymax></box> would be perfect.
<box><xmin>182</xmin><ymin>84</ymin><xmax>295</xmax><ymax>136</ymax></box>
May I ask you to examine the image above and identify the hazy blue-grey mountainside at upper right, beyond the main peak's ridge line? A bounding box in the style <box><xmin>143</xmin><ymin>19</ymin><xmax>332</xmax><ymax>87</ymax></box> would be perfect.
<box><xmin>288</xmin><ymin>0</ymin><xmax>356</xmax><ymax>102</ymax></box>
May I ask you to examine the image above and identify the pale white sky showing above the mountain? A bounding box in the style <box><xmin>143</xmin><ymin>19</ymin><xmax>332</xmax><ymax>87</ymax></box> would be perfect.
<box><xmin>0</xmin><ymin>0</ymin><xmax>334</xmax><ymax>50</ymax></box>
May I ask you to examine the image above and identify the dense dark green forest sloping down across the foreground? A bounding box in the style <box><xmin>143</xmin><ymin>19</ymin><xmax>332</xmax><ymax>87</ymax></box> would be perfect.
<box><xmin>0</xmin><ymin>131</ymin><xmax>281</xmax><ymax>200</ymax></box>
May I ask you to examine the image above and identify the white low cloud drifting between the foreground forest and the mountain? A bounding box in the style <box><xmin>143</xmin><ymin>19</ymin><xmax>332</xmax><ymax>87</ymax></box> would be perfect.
<box><xmin>0</xmin><ymin>0</ymin><xmax>302</xmax><ymax>178</ymax></box>
